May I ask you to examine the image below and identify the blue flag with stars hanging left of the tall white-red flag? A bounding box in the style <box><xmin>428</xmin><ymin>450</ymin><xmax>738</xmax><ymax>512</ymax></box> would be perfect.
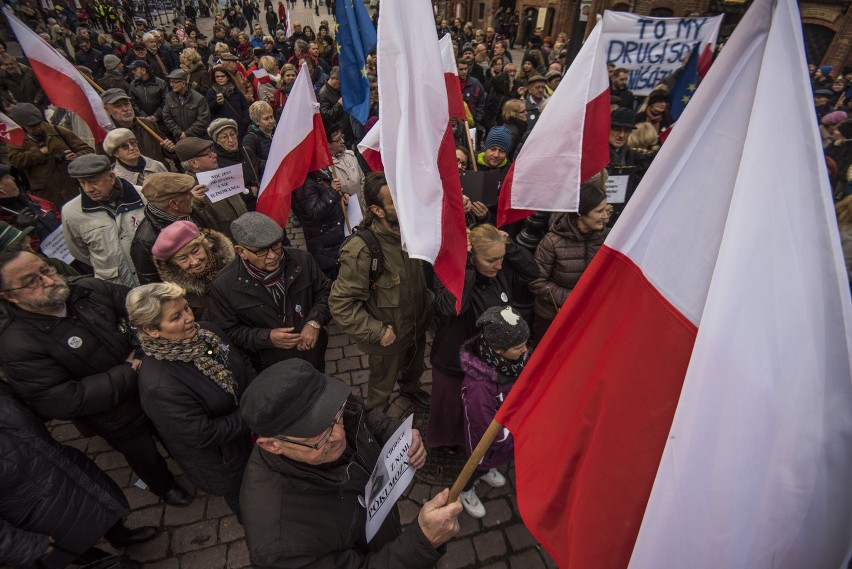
<box><xmin>335</xmin><ymin>0</ymin><xmax>376</xmax><ymax>124</ymax></box>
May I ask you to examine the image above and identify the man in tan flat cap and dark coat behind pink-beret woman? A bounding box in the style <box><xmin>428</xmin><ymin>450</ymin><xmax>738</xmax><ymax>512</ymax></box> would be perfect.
<box><xmin>130</xmin><ymin>172</ymin><xmax>215</xmax><ymax>284</ymax></box>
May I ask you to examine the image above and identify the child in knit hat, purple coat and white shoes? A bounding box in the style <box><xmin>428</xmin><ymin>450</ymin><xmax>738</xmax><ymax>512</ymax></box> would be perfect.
<box><xmin>460</xmin><ymin>306</ymin><xmax>530</xmax><ymax>518</ymax></box>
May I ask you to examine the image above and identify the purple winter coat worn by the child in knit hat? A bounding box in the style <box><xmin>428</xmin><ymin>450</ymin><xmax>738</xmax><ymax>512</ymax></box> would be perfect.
<box><xmin>459</xmin><ymin>336</ymin><xmax>515</xmax><ymax>471</ymax></box>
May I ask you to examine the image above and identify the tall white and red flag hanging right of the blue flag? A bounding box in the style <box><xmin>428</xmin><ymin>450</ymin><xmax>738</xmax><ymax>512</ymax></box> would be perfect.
<box><xmin>373</xmin><ymin>0</ymin><xmax>467</xmax><ymax>307</ymax></box>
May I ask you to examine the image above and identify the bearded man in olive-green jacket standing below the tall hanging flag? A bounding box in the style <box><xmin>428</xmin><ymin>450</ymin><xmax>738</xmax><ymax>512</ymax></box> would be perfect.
<box><xmin>329</xmin><ymin>172</ymin><xmax>435</xmax><ymax>410</ymax></box>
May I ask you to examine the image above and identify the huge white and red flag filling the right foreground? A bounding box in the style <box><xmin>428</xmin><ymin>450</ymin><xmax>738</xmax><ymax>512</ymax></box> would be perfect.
<box><xmin>496</xmin><ymin>0</ymin><xmax>852</xmax><ymax>569</ymax></box>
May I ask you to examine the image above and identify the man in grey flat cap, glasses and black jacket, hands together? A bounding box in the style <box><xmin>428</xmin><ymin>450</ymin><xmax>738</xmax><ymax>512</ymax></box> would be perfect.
<box><xmin>210</xmin><ymin>212</ymin><xmax>331</xmax><ymax>370</ymax></box>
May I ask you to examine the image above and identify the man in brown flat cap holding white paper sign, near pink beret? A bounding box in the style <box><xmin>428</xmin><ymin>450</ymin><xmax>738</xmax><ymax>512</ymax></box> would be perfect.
<box><xmin>175</xmin><ymin>136</ymin><xmax>248</xmax><ymax>237</ymax></box>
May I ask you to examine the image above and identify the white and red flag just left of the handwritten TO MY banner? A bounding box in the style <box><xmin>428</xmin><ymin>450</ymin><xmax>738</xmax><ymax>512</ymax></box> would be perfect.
<box><xmin>497</xmin><ymin>22</ymin><xmax>610</xmax><ymax>225</ymax></box>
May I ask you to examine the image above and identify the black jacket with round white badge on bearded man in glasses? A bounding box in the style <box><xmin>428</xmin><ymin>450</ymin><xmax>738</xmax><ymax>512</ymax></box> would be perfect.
<box><xmin>0</xmin><ymin>277</ymin><xmax>147</xmax><ymax>433</ymax></box>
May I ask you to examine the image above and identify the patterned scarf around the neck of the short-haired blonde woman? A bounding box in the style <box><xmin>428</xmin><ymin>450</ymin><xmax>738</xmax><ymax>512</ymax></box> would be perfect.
<box><xmin>139</xmin><ymin>324</ymin><xmax>238</xmax><ymax>403</ymax></box>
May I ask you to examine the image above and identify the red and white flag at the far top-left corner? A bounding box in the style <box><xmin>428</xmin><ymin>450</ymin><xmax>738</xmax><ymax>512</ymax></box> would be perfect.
<box><xmin>3</xmin><ymin>6</ymin><xmax>112</xmax><ymax>142</ymax></box>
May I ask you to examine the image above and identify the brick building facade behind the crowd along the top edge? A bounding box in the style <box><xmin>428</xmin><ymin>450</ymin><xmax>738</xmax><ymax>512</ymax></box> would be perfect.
<box><xmin>434</xmin><ymin>0</ymin><xmax>852</xmax><ymax>74</ymax></box>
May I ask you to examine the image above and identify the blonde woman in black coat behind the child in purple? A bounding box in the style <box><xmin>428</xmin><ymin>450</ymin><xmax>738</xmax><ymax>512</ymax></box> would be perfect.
<box><xmin>426</xmin><ymin>224</ymin><xmax>538</xmax><ymax>448</ymax></box>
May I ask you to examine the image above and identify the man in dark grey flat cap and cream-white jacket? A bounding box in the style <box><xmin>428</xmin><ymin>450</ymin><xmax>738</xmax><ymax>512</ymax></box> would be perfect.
<box><xmin>62</xmin><ymin>154</ymin><xmax>145</xmax><ymax>287</ymax></box>
